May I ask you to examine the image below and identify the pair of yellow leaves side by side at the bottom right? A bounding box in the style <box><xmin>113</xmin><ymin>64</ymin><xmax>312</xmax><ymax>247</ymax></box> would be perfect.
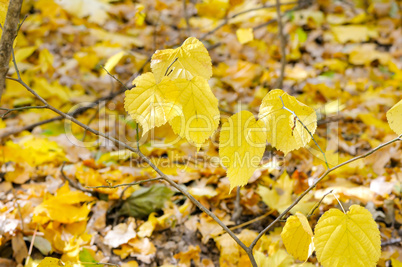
<box><xmin>278</xmin><ymin>205</ymin><xmax>381</xmax><ymax>267</ymax></box>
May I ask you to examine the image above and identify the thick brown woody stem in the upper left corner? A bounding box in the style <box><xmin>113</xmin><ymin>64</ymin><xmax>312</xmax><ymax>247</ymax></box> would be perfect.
<box><xmin>0</xmin><ymin>0</ymin><xmax>22</xmax><ymax>100</ymax></box>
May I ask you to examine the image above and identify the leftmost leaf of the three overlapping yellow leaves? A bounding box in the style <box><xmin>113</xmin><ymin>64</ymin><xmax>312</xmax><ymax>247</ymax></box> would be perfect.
<box><xmin>124</xmin><ymin>72</ymin><xmax>178</xmax><ymax>135</ymax></box>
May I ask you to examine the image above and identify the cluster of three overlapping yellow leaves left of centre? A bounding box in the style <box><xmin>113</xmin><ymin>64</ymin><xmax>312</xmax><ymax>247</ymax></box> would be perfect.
<box><xmin>124</xmin><ymin>37</ymin><xmax>220</xmax><ymax>149</ymax></box>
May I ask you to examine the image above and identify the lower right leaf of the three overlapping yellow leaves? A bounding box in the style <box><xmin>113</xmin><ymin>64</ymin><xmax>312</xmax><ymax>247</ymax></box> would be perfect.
<box><xmin>166</xmin><ymin>76</ymin><xmax>220</xmax><ymax>149</ymax></box>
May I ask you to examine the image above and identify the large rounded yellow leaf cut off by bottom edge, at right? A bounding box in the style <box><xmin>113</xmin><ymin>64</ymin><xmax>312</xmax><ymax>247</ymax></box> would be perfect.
<box><xmin>314</xmin><ymin>205</ymin><xmax>381</xmax><ymax>267</ymax></box>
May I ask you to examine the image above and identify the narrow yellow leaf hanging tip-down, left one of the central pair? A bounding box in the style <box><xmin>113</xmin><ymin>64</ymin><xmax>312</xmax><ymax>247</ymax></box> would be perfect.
<box><xmin>219</xmin><ymin>110</ymin><xmax>266</xmax><ymax>190</ymax></box>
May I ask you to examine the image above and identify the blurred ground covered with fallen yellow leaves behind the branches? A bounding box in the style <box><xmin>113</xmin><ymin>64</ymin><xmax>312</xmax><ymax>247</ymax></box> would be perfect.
<box><xmin>0</xmin><ymin>0</ymin><xmax>402</xmax><ymax>267</ymax></box>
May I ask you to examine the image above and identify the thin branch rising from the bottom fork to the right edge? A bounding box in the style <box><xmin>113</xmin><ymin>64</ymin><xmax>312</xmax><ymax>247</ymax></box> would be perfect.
<box><xmin>249</xmin><ymin>135</ymin><xmax>402</xmax><ymax>250</ymax></box>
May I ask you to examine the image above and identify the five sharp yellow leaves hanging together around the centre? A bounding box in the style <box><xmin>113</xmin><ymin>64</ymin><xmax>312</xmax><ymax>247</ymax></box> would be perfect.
<box><xmin>124</xmin><ymin>40</ymin><xmax>317</xmax><ymax>190</ymax></box>
